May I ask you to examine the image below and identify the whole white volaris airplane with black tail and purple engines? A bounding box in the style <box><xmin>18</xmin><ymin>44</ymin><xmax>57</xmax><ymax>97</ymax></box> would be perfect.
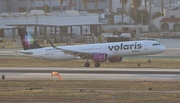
<box><xmin>17</xmin><ymin>28</ymin><xmax>166</xmax><ymax>67</ymax></box>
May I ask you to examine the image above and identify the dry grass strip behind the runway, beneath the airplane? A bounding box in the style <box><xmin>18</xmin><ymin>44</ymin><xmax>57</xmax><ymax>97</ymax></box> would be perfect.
<box><xmin>0</xmin><ymin>57</ymin><xmax>180</xmax><ymax>68</ymax></box>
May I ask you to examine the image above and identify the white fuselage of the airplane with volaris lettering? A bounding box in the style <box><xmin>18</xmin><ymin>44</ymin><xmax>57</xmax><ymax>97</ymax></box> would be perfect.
<box><xmin>18</xmin><ymin>40</ymin><xmax>166</xmax><ymax>60</ymax></box>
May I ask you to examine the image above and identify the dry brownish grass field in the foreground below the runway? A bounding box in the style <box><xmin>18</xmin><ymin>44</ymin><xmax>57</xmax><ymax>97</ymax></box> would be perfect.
<box><xmin>0</xmin><ymin>80</ymin><xmax>180</xmax><ymax>103</ymax></box>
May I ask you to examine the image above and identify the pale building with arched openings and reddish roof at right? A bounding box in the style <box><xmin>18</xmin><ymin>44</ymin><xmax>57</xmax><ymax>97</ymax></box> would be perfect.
<box><xmin>151</xmin><ymin>5</ymin><xmax>180</xmax><ymax>32</ymax></box>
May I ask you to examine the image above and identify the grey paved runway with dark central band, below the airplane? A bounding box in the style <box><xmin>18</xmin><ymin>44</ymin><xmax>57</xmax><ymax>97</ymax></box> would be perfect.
<box><xmin>0</xmin><ymin>67</ymin><xmax>180</xmax><ymax>81</ymax></box>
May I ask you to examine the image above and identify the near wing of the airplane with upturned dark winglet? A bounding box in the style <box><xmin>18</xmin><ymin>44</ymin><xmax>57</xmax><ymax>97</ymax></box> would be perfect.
<box><xmin>49</xmin><ymin>40</ymin><xmax>94</xmax><ymax>59</ymax></box>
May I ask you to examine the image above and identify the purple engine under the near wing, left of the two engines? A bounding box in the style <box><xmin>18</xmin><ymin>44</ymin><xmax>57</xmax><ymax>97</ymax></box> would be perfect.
<box><xmin>93</xmin><ymin>53</ymin><xmax>107</xmax><ymax>62</ymax></box>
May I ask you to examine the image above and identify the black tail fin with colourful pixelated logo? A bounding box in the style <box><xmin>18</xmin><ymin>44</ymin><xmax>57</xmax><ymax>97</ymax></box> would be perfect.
<box><xmin>18</xmin><ymin>28</ymin><xmax>42</xmax><ymax>50</ymax></box>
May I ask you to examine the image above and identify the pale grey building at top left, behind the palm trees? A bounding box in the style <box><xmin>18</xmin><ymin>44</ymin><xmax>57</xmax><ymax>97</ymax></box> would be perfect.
<box><xmin>0</xmin><ymin>0</ymin><xmax>109</xmax><ymax>13</ymax></box>
